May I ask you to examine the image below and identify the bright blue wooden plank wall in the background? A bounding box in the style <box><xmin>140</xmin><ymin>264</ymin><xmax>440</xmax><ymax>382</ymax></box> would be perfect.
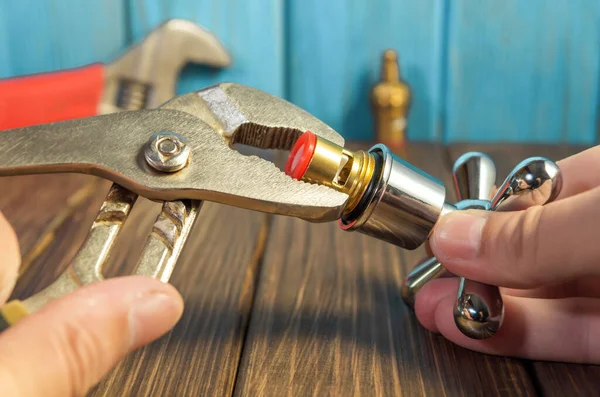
<box><xmin>0</xmin><ymin>0</ymin><xmax>600</xmax><ymax>144</ymax></box>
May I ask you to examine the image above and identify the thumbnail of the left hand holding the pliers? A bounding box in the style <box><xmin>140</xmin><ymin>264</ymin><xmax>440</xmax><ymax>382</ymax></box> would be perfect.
<box><xmin>129</xmin><ymin>292</ymin><xmax>182</xmax><ymax>348</ymax></box>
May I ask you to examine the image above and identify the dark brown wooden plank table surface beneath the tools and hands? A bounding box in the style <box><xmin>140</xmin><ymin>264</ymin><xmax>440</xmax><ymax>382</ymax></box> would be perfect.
<box><xmin>0</xmin><ymin>144</ymin><xmax>600</xmax><ymax>396</ymax></box>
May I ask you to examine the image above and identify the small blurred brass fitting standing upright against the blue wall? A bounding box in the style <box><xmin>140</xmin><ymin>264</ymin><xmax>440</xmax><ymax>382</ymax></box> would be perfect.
<box><xmin>371</xmin><ymin>50</ymin><xmax>411</xmax><ymax>149</ymax></box>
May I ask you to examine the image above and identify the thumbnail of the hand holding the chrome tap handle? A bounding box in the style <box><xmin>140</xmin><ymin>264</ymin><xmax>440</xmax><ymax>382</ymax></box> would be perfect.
<box><xmin>431</xmin><ymin>211</ymin><xmax>488</xmax><ymax>260</ymax></box>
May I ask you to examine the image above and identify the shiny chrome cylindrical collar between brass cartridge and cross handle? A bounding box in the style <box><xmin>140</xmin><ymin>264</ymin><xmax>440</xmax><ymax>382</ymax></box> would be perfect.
<box><xmin>340</xmin><ymin>145</ymin><xmax>446</xmax><ymax>250</ymax></box>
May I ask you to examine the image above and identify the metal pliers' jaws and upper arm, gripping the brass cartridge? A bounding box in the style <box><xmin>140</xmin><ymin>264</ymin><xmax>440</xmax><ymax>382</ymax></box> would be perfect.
<box><xmin>0</xmin><ymin>83</ymin><xmax>348</xmax><ymax>222</ymax></box>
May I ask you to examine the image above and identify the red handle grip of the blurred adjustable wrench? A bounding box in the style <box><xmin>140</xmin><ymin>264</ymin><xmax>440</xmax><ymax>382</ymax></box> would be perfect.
<box><xmin>0</xmin><ymin>63</ymin><xmax>105</xmax><ymax>130</ymax></box>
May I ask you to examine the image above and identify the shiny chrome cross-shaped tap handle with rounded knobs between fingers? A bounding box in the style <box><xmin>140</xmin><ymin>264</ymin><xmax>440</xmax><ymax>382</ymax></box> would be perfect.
<box><xmin>402</xmin><ymin>152</ymin><xmax>562</xmax><ymax>339</ymax></box>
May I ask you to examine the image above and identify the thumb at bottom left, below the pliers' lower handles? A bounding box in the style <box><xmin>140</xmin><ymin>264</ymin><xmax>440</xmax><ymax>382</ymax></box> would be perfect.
<box><xmin>0</xmin><ymin>276</ymin><xmax>183</xmax><ymax>396</ymax></box>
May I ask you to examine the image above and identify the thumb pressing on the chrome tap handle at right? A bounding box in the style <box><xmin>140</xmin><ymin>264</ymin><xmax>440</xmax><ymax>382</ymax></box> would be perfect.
<box><xmin>430</xmin><ymin>188</ymin><xmax>600</xmax><ymax>288</ymax></box>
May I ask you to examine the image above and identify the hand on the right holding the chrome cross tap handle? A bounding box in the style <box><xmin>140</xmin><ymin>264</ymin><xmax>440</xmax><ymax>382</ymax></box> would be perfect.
<box><xmin>415</xmin><ymin>146</ymin><xmax>600</xmax><ymax>364</ymax></box>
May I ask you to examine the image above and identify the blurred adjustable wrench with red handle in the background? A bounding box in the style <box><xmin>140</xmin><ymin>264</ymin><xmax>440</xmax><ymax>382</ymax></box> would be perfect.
<box><xmin>0</xmin><ymin>19</ymin><xmax>231</xmax><ymax>129</ymax></box>
